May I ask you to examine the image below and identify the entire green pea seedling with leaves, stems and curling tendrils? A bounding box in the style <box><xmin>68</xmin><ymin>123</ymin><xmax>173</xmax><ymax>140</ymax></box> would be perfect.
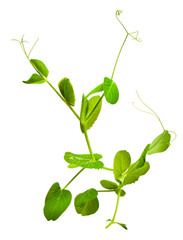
<box><xmin>13</xmin><ymin>11</ymin><xmax>176</xmax><ymax>230</ymax></box>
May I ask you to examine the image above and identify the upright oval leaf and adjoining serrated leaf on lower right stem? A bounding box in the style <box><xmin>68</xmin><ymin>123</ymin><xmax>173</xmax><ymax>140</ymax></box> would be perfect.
<box><xmin>113</xmin><ymin>144</ymin><xmax>150</xmax><ymax>186</ymax></box>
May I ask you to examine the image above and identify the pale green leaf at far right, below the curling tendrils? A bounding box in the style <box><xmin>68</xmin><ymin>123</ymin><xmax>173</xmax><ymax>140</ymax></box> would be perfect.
<box><xmin>147</xmin><ymin>130</ymin><xmax>171</xmax><ymax>155</ymax></box>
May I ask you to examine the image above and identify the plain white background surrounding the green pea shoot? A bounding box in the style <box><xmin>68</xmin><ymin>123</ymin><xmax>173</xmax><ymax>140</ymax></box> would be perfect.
<box><xmin>0</xmin><ymin>0</ymin><xmax>183</xmax><ymax>240</ymax></box>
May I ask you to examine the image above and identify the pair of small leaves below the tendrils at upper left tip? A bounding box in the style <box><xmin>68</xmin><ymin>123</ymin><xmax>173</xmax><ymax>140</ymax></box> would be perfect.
<box><xmin>23</xmin><ymin>59</ymin><xmax>49</xmax><ymax>84</ymax></box>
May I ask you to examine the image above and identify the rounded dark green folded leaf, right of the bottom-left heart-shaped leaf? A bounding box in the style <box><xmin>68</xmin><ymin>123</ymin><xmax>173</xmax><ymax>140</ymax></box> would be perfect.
<box><xmin>74</xmin><ymin>188</ymin><xmax>99</xmax><ymax>216</ymax></box>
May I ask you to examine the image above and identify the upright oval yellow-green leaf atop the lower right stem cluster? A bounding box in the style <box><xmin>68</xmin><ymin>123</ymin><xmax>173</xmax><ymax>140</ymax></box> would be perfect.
<box><xmin>113</xmin><ymin>150</ymin><xmax>131</xmax><ymax>180</ymax></box>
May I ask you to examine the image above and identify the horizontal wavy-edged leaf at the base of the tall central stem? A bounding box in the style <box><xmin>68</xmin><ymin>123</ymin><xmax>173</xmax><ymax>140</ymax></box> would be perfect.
<box><xmin>64</xmin><ymin>152</ymin><xmax>104</xmax><ymax>169</ymax></box>
